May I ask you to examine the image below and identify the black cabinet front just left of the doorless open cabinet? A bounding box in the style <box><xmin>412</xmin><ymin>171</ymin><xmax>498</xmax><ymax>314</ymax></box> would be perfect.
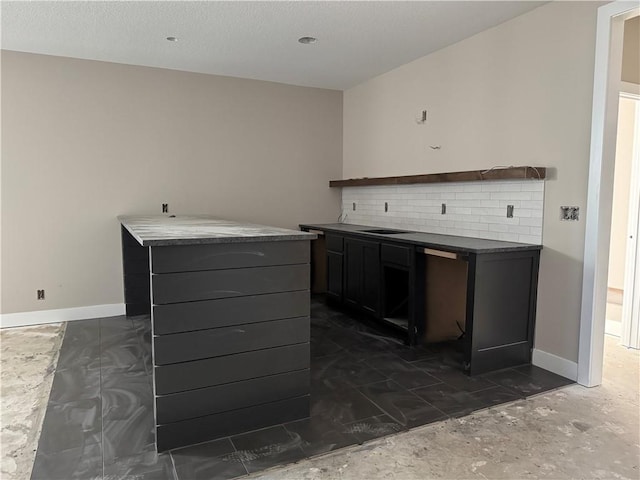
<box><xmin>344</xmin><ymin>238</ymin><xmax>380</xmax><ymax>316</ymax></box>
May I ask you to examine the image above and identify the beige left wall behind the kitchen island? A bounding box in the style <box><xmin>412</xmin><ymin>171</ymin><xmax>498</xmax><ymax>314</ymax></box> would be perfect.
<box><xmin>2</xmin><ymin>51</ymin><xmax>342</xmax><ymax>313</ymax></box>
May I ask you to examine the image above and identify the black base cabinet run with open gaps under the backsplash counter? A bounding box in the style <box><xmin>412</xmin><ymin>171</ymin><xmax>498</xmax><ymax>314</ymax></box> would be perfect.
<box><xmin>301</xmin><ymin>225</ymin><xmax>541</xmax><ymax>375</ymax></box>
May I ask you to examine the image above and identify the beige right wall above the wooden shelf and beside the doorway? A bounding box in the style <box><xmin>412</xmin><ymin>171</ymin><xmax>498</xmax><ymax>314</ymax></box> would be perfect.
<box><xmin>343</xmin><ymin>2</ymin><xmax>601</xmax><ymax>362</ymax></box>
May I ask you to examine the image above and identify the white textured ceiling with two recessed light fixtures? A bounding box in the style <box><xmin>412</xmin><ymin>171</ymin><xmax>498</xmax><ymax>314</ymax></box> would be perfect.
<box><xmin>1</xmin><ymin>1</ymin><xmax>545</xmax><ymax>90</ymax></box>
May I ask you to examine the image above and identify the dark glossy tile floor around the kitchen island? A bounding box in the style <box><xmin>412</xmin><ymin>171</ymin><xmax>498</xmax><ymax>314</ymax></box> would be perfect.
<box><xmin>31</xmin><ymin>299</ymin><xmax>572</xmax><ymax>480</ymax></box>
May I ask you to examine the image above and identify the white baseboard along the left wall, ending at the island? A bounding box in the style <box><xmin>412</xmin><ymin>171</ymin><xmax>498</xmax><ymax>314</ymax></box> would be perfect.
<box><xmin>0</xmin><ymin>303</ymin><xmax>125</xmax><ymax>328</ymax></box>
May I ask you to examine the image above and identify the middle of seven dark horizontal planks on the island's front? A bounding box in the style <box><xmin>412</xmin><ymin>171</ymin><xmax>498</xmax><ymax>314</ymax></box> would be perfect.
<box><xmin>153</xmin><ymin>317</ymin><xmax>310</xmax><ymax>365</ymax></box>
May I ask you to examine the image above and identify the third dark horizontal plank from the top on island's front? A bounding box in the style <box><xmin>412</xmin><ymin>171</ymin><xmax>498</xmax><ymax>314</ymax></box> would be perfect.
<box><xmin>152</xmin><ymin>290</ymin><xmax>309</xmax><ymax>335</ymax></box>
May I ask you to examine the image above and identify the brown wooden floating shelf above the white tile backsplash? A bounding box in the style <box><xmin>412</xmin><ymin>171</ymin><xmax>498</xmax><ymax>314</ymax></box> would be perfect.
<box><xmin>329</xmin><ymin>167</ymin><xmax>547</xmax><ymax>187</ymax></box>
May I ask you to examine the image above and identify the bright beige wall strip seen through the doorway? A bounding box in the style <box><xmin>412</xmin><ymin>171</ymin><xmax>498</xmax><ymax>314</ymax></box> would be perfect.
<box><xmin>608</xmin><ymin>97</ymin><xmax>636</xmax><ymax>290</ymax></box>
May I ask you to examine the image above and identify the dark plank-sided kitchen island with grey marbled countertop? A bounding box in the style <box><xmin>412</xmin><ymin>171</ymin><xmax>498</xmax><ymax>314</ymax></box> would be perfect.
<box><xmin>118</xmin><ymin>215</ymin><xmax>316</xmax><ymax>452</ymax></box>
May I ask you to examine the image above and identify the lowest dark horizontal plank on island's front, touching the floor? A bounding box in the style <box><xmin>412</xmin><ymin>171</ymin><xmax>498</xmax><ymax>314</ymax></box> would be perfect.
<box><xmin>156</xmin><ymin>395</ymin><xmax>309</xmax><ymax>452</ymax></box>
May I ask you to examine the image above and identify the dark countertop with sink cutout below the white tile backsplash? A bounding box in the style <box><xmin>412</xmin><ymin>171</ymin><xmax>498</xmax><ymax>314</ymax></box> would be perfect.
<box><xmin>300</xmin><ymin>223</ymin><xmax>542</xmax><ymax>254</ymax></box>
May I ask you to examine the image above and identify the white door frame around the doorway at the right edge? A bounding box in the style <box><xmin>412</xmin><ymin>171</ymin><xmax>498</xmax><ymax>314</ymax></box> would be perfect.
<box><xmin>578</xmin><ymin>1</ymin><xmax>638</xmax><ymax>387</ymax></box>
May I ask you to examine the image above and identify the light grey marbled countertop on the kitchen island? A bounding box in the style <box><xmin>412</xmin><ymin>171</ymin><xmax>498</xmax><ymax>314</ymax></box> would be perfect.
<box><xmin>118</xmin><ymin>215</ymin><xmax>317</xmax><ymax>247</ymax></box>
